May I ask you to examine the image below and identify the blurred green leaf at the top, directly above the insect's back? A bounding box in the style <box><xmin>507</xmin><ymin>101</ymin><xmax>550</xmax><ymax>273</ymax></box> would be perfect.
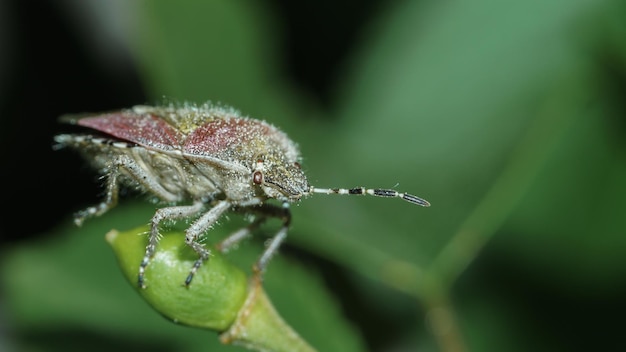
<box><xmin>130</xmin><ymin>0</ymin><xmax>312</xmax><ymax>133</ymax></box>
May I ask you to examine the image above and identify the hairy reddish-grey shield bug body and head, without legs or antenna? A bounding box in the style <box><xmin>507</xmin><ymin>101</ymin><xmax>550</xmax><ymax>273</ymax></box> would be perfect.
<box><xmin>62</xmin><ymin>106</ymin><xmax>308</xmax><ymax>202</ymax></box>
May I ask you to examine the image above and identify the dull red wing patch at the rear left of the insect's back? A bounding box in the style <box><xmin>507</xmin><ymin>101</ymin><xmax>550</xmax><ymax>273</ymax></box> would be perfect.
<box><xmin>76</xmin><ymin>112</ymin><xmax>183</xmax><ymax>150</ymax></box>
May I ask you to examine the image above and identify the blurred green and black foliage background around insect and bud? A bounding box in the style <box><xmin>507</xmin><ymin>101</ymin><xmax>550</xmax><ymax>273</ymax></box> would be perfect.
<box><xmin>0</xmin><ymin>0</ymin><xmax>626</xmax><ymax>351</ymax></box>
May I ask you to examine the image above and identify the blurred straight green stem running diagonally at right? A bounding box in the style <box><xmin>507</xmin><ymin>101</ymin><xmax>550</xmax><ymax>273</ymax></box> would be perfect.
<box><xmin>427</xmin><ymin>78</ymin><xmax>584</xmax><ymax>288</ymax></box>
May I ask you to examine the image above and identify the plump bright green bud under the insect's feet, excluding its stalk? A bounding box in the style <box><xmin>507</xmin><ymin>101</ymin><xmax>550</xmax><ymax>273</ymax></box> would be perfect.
<box><xmin>106</xmin><ymin>227</ymin><xmax>247</xmax><ymax>331</ymax></box>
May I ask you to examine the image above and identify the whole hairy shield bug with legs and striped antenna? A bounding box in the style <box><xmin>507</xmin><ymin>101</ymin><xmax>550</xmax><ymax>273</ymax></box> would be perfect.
<box><xmin>54</xmin><ymin>103</ymin><xmax>430</xmax><ymax>288</ymax></box>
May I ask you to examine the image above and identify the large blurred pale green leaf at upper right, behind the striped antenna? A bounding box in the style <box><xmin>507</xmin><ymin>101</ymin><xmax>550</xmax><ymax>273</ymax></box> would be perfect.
<box><xmin>294</xmin><ymin>0</ymin><xmax>606</xmax><ymax>292</ymax></box>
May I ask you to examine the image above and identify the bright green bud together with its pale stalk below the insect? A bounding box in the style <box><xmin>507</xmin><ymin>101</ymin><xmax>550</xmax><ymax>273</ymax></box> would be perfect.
<box><xmin>106</xmin><ymin>227</ymin><xmax>315</xmax><ymax>352</ymax></box>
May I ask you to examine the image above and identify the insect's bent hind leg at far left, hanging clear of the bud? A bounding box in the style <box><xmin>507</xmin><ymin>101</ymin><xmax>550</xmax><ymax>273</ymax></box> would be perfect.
<box><xmin>74</xmin><ymin>154</ymin><xmax>178</xmax><ymax>226</ymax></box>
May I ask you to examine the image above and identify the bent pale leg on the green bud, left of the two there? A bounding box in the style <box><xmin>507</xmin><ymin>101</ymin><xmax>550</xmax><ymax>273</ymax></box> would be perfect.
<box><xmin>137</xmin><ymin>201</ymin><xmax>204</xmax><ymax>288</ymax></box>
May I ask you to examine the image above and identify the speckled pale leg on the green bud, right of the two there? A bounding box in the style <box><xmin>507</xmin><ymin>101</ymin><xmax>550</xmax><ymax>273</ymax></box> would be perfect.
<box><xmin>185</xmin><ymin>200</ymin><xmax>231</xmax><ymax>286</ymax></box>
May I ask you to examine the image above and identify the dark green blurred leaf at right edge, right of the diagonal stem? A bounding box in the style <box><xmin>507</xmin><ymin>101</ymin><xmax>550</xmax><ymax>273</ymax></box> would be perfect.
<box><xmin>499</xmin><ymin>93</ymin><xmax>626</xmax><ymax>290</ymax></box>
